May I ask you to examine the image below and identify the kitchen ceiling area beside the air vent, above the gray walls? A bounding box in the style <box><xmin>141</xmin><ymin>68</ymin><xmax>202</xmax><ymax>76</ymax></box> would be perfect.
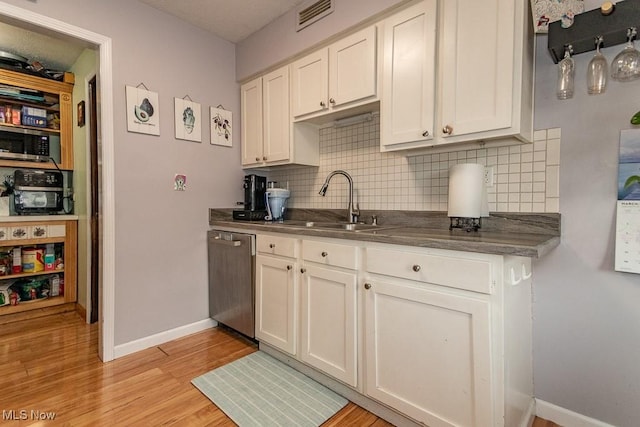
<box><xmin>140</xmin><ymin>0</ymin><xmax>305</xmax><ymax>43</ymax></box>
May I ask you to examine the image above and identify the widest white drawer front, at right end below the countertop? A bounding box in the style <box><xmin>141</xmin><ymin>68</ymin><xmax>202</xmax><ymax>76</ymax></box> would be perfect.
<box><xmin>366</xmin><ymin>248</ymin><xmax>496</xmax><ymax>294</ymax></box>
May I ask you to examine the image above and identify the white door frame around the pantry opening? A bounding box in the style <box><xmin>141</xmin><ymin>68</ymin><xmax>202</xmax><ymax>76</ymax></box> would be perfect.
<box><xmin>0</xmin><ymin>2</ymin><xmax>115</xmax><ymax>362</ymax></box>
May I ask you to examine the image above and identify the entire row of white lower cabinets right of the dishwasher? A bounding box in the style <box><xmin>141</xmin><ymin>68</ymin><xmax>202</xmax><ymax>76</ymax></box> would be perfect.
<box><xmin>256</xmin><ymin>235</ymin><xmax>533</xmax><ymax>427</ymax></box>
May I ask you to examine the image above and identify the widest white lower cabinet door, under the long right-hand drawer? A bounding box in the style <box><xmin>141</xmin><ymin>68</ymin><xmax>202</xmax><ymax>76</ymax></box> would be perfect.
<box><xmin>365</xmin><ymin>279</ymin><xmax>495</xmax><ymax>427</ymax></box>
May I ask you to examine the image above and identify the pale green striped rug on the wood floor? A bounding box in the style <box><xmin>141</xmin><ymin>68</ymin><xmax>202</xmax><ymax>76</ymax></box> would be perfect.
<box><xmin>191</xmin><ymin>351</ymin><xmax>347</xmax><ymax>427</ymax></box>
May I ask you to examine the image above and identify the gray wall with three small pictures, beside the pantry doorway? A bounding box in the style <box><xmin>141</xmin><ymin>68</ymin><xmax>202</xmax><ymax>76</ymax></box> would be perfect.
<box><xmin>0</xmin><ymin>0</ymin><xmax>244</xmax><ymax>345</ymax></box>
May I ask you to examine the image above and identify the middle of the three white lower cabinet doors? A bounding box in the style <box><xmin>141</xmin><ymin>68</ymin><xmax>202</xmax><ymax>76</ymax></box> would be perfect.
<box><xmin>300</xmin><ymin>265</ymin><xmax>357</xmax><ymax>387</ymax></box>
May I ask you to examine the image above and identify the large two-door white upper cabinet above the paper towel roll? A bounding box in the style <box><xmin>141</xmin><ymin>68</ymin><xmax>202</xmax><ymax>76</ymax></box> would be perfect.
<box><xmin>381</xmin><ymin>0</ymin><xmax>534</xmax><ymax>151</ymax></box>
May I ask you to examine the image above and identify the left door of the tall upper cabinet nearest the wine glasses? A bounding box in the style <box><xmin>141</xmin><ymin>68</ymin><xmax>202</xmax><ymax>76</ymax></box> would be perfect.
<box><xmin>380</xmin><ymin>0</ymin><xmax>436</xmax><ymax>149</ymax></box>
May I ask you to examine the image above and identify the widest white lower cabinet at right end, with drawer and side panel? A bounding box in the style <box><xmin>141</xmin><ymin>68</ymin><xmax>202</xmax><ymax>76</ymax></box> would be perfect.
<box><xmin>362</xmin><ymin>245</ymin><xmax>533</xmax><ymax>427</ymax></box>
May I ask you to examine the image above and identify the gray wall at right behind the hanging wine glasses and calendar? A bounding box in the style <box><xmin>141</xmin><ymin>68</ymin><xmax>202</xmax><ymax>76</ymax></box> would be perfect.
<box><xmin>533</xmin><ymin>13</ymin><xmax>640</xmax><ymax>427</ymax></box>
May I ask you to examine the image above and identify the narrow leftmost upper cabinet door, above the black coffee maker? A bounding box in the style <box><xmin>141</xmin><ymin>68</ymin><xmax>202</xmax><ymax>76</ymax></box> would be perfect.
<box><xmin>240</xmin><ymin>78</ymin><xmax>263</xmax><ymax>166</ymax></box>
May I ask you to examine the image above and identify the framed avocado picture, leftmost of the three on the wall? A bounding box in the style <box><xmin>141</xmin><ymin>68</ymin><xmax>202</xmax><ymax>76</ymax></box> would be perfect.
<box><xmin>126</xmin><ymin>86</ymin><xmax>160</xmax><ymax>135</ymax></box>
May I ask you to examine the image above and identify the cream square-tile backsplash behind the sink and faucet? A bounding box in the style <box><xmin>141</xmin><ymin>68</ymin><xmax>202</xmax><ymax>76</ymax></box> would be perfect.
<box><xmin>267</xmin><ymin>115</ymin><xmax>560</xmax><ymax>213</ymax></box>
